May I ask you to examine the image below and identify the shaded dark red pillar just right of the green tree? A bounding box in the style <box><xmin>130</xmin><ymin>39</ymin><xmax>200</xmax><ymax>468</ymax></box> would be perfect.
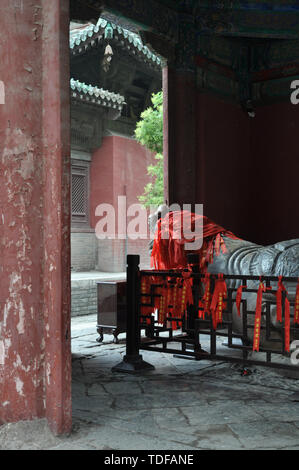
<box><xmin>163</xmin><ymin>67</ymin><xmax>198</xmax><ymax>204</ymax></box>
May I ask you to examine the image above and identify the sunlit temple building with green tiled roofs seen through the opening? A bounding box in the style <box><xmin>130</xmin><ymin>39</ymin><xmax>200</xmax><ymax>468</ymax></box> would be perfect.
<box><xmin>70</xmin><ymin>14</ymin><xmax>162</xmax><ymax>272</ymax></box>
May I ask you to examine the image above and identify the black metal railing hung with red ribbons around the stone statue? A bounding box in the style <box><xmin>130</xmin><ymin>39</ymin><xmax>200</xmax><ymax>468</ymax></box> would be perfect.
<box><xmin>113</xmin><ymin>255</ymin><xmax>299</xmax><ymax>372</ymax></box>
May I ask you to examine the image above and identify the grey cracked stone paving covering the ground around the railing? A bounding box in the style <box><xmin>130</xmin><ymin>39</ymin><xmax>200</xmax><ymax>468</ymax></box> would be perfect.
<box><xmin>0</xmin><ymin>315</ymin><xmax>299</xmax><ymax>451</ymax></box>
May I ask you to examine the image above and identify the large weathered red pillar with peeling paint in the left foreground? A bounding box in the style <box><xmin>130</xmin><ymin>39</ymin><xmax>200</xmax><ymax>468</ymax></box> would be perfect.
<box><xmin>0</xmin><ymin>0</ymin><xmax>71</xmax><ymax>434</ymax></box>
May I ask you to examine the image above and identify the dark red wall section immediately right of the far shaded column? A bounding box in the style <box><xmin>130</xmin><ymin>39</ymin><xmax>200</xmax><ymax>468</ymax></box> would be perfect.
<box><xmin>197</xmin><ymin>94</ymin><xmax>250</xmax><ymax>239</ymax></box>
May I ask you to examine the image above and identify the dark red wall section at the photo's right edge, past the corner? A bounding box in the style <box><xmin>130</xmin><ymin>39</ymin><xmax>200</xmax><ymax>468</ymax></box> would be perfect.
<box><xmin>249</xmin><ymin>103</ymin><xmax>299</xmax><ymax>242</ymax></box>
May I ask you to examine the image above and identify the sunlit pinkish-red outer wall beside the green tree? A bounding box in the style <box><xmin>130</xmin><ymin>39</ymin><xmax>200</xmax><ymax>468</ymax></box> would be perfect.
<box><xmin>90</xmin><ymin>136</ymin><xmax>155</xmax><ymax>271</ymax></box>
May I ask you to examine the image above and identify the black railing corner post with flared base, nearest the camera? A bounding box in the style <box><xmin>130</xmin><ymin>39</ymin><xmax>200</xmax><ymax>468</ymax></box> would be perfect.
<box><xmin>112</xmin><ymin>255</ymin><xmax>155</xmax><ymax>374</ymax></box>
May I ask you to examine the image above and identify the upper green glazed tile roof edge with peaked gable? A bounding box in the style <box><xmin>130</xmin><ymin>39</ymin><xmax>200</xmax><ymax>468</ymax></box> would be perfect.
<box><xmin>70</xmin><ymin>18</ymin><xmax>162</xmax><ymax>66</ymax></box>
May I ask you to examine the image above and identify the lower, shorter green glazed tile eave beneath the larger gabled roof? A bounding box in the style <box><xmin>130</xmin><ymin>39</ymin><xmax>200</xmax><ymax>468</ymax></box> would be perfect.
<box><xmin>70</xmin><ymin>78</ymin><xmax>126</xmax><ymax>111</ymax></box>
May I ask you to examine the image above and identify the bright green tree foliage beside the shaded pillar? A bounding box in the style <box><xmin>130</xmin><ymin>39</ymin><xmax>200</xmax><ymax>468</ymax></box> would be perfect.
<box><xmin>135</xmin><ymin>91</ymin><xmax>164</xmax><ymax>207</ymax></box>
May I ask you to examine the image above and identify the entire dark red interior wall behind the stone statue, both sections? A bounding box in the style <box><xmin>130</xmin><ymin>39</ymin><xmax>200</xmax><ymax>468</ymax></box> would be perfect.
<box><xmin>196</xmin><ymin>94</ymin><xmax>299</xmax><ymax>244</ymax></box>
